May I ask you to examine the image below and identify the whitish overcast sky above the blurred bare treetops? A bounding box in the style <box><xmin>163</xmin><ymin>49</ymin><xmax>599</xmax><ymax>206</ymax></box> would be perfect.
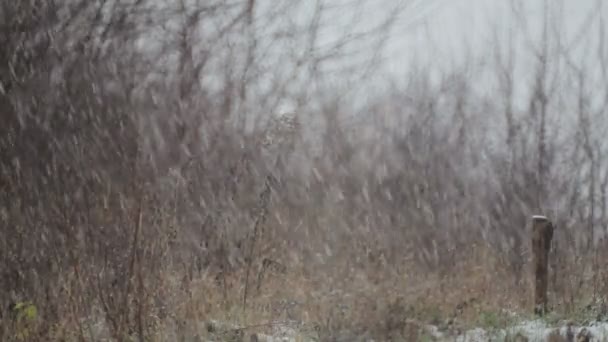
<box><xmin>308</xmin><ymin>0</ymin><xmax>608</xmax><ymax>150</ymax></box>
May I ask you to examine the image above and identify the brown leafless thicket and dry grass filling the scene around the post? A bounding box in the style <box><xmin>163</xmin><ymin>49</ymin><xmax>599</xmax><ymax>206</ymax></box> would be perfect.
<box><xmin>0</xmin><ymin>0</ymin><xmax>608</xmax><ymax>341</ymax></box>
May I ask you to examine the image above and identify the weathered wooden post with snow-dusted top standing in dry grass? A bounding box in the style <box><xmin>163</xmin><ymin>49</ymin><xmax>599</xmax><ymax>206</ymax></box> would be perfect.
<box><xmin>532</xmin><ymin>215</ymin><xmax>553</xmax><ymax>316</ymax></box>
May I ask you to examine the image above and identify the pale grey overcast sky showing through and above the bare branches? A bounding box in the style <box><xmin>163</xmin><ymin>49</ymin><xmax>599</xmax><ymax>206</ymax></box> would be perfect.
<box><xmin>270</xmin><ymin>0</ymin><xmax>608</xmax><ymax>121</ymax></box>
